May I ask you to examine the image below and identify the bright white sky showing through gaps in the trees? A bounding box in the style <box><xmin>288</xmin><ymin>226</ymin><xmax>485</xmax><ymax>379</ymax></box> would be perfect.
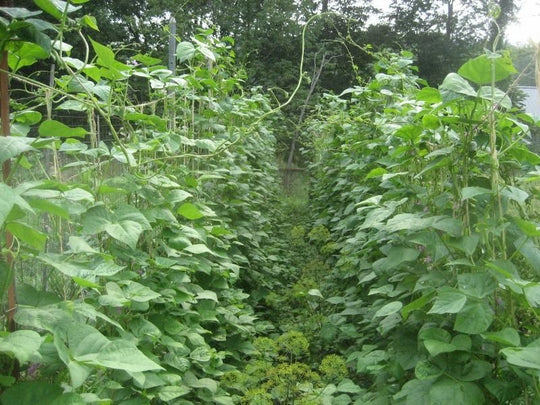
<box><xmin>373</xmin><ymin>0</ymin><xmax>540</xmax><ymax>45</ymax></box>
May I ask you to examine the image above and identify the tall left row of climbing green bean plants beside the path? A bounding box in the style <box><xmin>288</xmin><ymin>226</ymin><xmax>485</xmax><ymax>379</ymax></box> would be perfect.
<box><xmin>0</xmin><ymin>0</ymin><xmax>277</xmax><ymax>404</ymax></box>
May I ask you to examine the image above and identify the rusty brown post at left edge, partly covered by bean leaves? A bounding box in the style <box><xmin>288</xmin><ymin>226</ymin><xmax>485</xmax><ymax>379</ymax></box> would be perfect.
<box><xmin>0</xmin><ymin>0</ymin><xmax>17</xmax><ymax>338</ymax></box>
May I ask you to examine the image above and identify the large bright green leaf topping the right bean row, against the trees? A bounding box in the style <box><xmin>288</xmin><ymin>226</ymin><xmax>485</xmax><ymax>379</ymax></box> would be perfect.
<box><xmin>458</xmin><ymin>54</ymin><xmax>517</xmax><ymax>84</ymax></box>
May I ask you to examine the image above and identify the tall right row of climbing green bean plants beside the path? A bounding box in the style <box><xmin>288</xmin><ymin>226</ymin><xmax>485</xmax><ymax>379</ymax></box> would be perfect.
<box><xmin>308</xmin><ymin>50</ymin><xmax>540</xmax><ymax>405</ymax></box>
